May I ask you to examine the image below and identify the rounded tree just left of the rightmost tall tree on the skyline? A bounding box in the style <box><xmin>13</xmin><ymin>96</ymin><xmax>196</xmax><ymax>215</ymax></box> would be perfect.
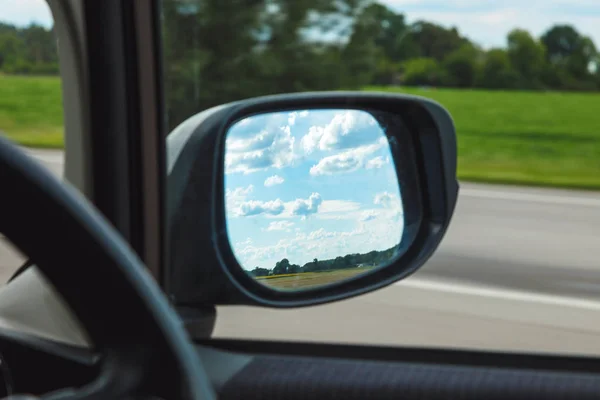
<box><xmin>508</xmin><ymin>29</ymin><xmax>546</xmax><ymax>87</ymax></box>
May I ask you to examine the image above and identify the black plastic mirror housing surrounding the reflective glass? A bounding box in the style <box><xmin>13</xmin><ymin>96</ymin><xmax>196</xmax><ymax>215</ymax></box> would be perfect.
<box><xmin>164</xmin><ymin>92</ymin><xmax>458</xmax><ymax>308</ymax></box>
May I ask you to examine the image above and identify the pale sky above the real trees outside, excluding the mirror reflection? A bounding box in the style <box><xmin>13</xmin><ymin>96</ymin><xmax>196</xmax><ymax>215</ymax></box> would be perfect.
<box><xmin>0</xmin><ymin>0</ymin><xmax>600</xmax><ymax>48</ymax></box>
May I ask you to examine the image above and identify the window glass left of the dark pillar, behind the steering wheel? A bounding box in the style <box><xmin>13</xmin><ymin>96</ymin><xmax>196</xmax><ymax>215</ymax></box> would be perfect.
<box><xmin>0</xmin><ymin>0</ymin><xmax>64</xmax><ymax>285</ymax></box>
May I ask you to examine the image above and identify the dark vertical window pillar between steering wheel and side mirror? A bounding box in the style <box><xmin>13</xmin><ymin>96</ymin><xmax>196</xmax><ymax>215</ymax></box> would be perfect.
<box><xmin>47</xmin><ymin>0</ymin><xmax>166</xmax><ymax>286</ymax></box>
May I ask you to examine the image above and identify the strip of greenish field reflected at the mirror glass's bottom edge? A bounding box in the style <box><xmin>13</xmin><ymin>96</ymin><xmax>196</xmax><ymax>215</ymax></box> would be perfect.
<box><xmin>255</xmin><ymin>267</ymin><xmax>373</xmax><ymax>290</ymax></box>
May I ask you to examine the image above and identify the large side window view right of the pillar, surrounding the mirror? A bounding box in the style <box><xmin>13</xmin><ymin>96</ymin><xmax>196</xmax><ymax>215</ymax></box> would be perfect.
<box><xmin>162</xmin><ymin>0</ymin><xmax>600</xmax><ymax>353</ymax></box>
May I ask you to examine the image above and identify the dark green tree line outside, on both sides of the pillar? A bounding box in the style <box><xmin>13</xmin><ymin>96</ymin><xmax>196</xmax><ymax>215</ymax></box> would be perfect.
<box><xmin>0</xmin><ymin>0</ymin><xmax>600</xmax><ymax>129</ymax></box>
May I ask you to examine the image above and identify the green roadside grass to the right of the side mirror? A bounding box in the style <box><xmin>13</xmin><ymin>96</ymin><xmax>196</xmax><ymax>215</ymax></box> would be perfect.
<box><xmin>365</xmin><ymin>86</ymin><xmax>600</xmax><ymax>189</ymax></box>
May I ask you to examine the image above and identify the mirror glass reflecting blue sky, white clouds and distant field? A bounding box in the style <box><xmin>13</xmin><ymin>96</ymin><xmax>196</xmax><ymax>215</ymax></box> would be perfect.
<box><xmin>224</xmin><ymin>109</ymin><xmax>404</xmax><ymax>290</ymax></box>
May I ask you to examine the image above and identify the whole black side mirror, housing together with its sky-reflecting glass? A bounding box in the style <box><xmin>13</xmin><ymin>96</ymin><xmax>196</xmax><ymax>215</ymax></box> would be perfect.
<box><xmin>167</xmin><ymin>92</ymin><xmax>458</xmax><ymax>307</ymax></box>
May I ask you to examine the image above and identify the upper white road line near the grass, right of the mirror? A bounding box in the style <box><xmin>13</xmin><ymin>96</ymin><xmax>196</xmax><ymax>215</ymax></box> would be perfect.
<box><xmin>459</xmin><ymin>189</ymin><xmax>600</xmax><ymax>207</ymax></box>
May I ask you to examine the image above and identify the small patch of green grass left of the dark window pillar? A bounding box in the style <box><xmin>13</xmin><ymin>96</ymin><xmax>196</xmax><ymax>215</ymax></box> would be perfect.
<box><xmin>0</xmin><ymin>74</ymin><xmax>64</xmax><ymax>148</ymax></box>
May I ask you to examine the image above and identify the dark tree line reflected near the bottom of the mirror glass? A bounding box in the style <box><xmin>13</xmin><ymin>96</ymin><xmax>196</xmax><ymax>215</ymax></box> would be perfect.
<box><xmin>250</xmin><ymin>246</ymin><xmax>398</xmax><ymax>277</ymax></box>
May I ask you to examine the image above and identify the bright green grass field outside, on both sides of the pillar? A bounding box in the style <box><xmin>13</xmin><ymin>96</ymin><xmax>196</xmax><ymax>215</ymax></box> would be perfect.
<box><xmin>0</xmin><ymin>75</ymin><xmax>600</xmax><ymax>189</ymax></box>
